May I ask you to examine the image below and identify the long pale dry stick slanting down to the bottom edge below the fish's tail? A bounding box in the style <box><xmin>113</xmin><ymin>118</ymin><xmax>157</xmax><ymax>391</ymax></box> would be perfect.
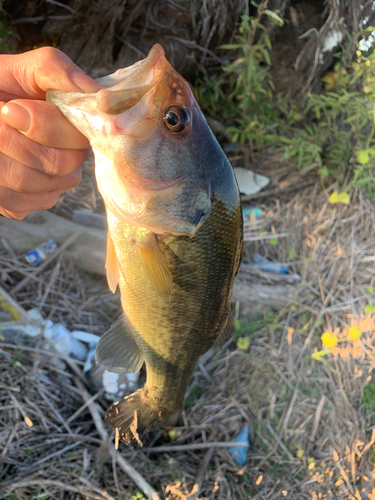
<box><xmin>75</xmin><ymin>379</ymin><xmax>160</xmax><ymax>500</ymax></box>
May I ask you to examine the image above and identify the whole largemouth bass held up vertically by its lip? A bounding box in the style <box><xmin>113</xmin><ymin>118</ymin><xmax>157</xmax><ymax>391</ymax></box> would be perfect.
<box><xmin>47</xmin><ymin>45</ymin><xmax>242</xmax><ymax>443</ymax></box>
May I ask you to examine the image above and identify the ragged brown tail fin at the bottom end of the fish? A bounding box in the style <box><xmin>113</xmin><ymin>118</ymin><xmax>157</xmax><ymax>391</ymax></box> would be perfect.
<box><xmin>106</xmin><ymin>388</ymin><xmax>182</xmax><ymax>446</ymax></box>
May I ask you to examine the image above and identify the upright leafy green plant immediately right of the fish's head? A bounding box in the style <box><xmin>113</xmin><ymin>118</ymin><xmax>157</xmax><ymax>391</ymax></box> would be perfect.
<box><xmin>195</xmin><ymin>2</ymin><xmax>284</xmax><ymax>149</ymax></box>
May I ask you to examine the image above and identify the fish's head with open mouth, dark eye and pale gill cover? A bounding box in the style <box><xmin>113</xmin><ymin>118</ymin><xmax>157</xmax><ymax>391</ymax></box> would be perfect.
<box><xmin>47</xmin><ymin>44</ymin><xmax>233</xmax><ymax>236</ymax></box>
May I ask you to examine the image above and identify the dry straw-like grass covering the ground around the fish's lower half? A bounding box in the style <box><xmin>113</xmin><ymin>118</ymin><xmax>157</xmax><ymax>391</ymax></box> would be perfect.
<box><xmin>0</xmin><ymin>166</ymin><xmax>375</xmax><ymax>500</ymax></box>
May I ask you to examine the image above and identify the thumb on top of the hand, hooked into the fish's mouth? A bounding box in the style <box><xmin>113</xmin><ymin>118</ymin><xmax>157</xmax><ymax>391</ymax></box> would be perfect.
<box><xmin>0</xmin><ymin>47</ymin><xmax>101</xmax><ymax>101</ymax></box>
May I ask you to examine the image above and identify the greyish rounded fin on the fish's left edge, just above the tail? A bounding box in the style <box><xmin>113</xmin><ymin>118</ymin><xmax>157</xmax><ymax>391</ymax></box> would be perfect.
<box><xmin>95</xmin><ymin>316</ymin><xmax>144</xmax><ymax>373</ymax></box>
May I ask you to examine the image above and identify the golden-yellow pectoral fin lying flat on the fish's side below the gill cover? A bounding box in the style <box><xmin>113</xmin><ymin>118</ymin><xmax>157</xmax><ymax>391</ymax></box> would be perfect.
<box><xmin>137</xmin><ymin>232</ymin><xmax>172</xmax><ymax>304</ymax></box>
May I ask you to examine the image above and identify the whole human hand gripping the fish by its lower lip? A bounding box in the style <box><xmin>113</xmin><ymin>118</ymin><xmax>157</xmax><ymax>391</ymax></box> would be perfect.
<box><xmin>0</xmin><ymin>47</ymin><xmax>101</xmax><ymax>220</ymax></box>
